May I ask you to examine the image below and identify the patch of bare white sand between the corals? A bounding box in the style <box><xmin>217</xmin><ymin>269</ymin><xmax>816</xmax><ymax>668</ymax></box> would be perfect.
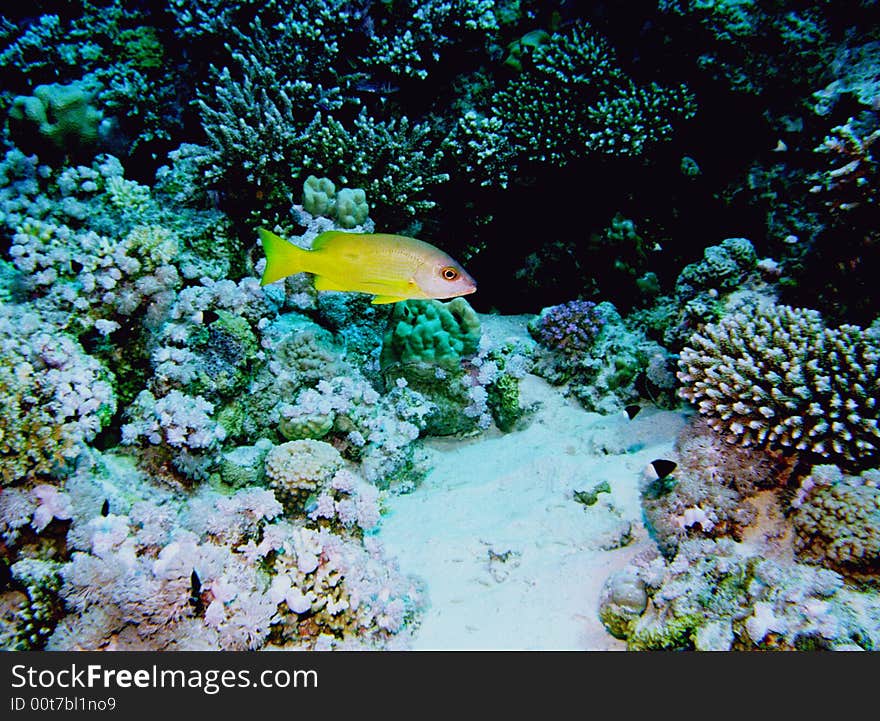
<box><xmin>379</xmin><ymin>362</ymin><xmax>683</xmax><ymax>650</ymax></box>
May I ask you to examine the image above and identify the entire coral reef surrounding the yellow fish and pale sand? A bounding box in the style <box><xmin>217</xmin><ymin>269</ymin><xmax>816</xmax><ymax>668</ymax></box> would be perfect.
<box><xmin>0</xmin><ymin>0</ymin><xmax>880</xmax><ymax>650</ymax></box>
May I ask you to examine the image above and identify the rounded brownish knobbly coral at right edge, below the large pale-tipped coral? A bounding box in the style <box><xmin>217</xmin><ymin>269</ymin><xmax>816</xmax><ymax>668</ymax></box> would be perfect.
<box><xmin>792</xmin><ymin>465</ymin><xmax>880</xmax><ymax>578</ymax></box>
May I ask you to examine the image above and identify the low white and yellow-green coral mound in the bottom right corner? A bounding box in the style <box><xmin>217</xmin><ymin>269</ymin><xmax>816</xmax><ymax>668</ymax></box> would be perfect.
<box><xmin>600</xmin><ymin>539</ymin><xmax>880</xmax><ymax>651</ymax></box>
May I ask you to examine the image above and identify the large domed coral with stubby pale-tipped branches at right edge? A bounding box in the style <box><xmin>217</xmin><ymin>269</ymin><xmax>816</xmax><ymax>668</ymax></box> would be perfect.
<box><xmin>678</xmin><ymin>306</ymin><xmax>880</xmax><ymax>465</ymax></box>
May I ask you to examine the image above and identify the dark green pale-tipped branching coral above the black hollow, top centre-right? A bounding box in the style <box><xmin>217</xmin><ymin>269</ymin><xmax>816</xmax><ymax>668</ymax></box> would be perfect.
<box><xmin>456</xmin><ymin>24</ymin><xmax>695</xmax><ymax>187</ymax></box>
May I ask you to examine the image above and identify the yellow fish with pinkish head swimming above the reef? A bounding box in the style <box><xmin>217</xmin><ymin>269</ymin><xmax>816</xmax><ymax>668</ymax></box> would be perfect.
<box><xmin>258</xmin><ymin>228</ymin><xmax>477</xmax><ymax>303</ymax></box>
